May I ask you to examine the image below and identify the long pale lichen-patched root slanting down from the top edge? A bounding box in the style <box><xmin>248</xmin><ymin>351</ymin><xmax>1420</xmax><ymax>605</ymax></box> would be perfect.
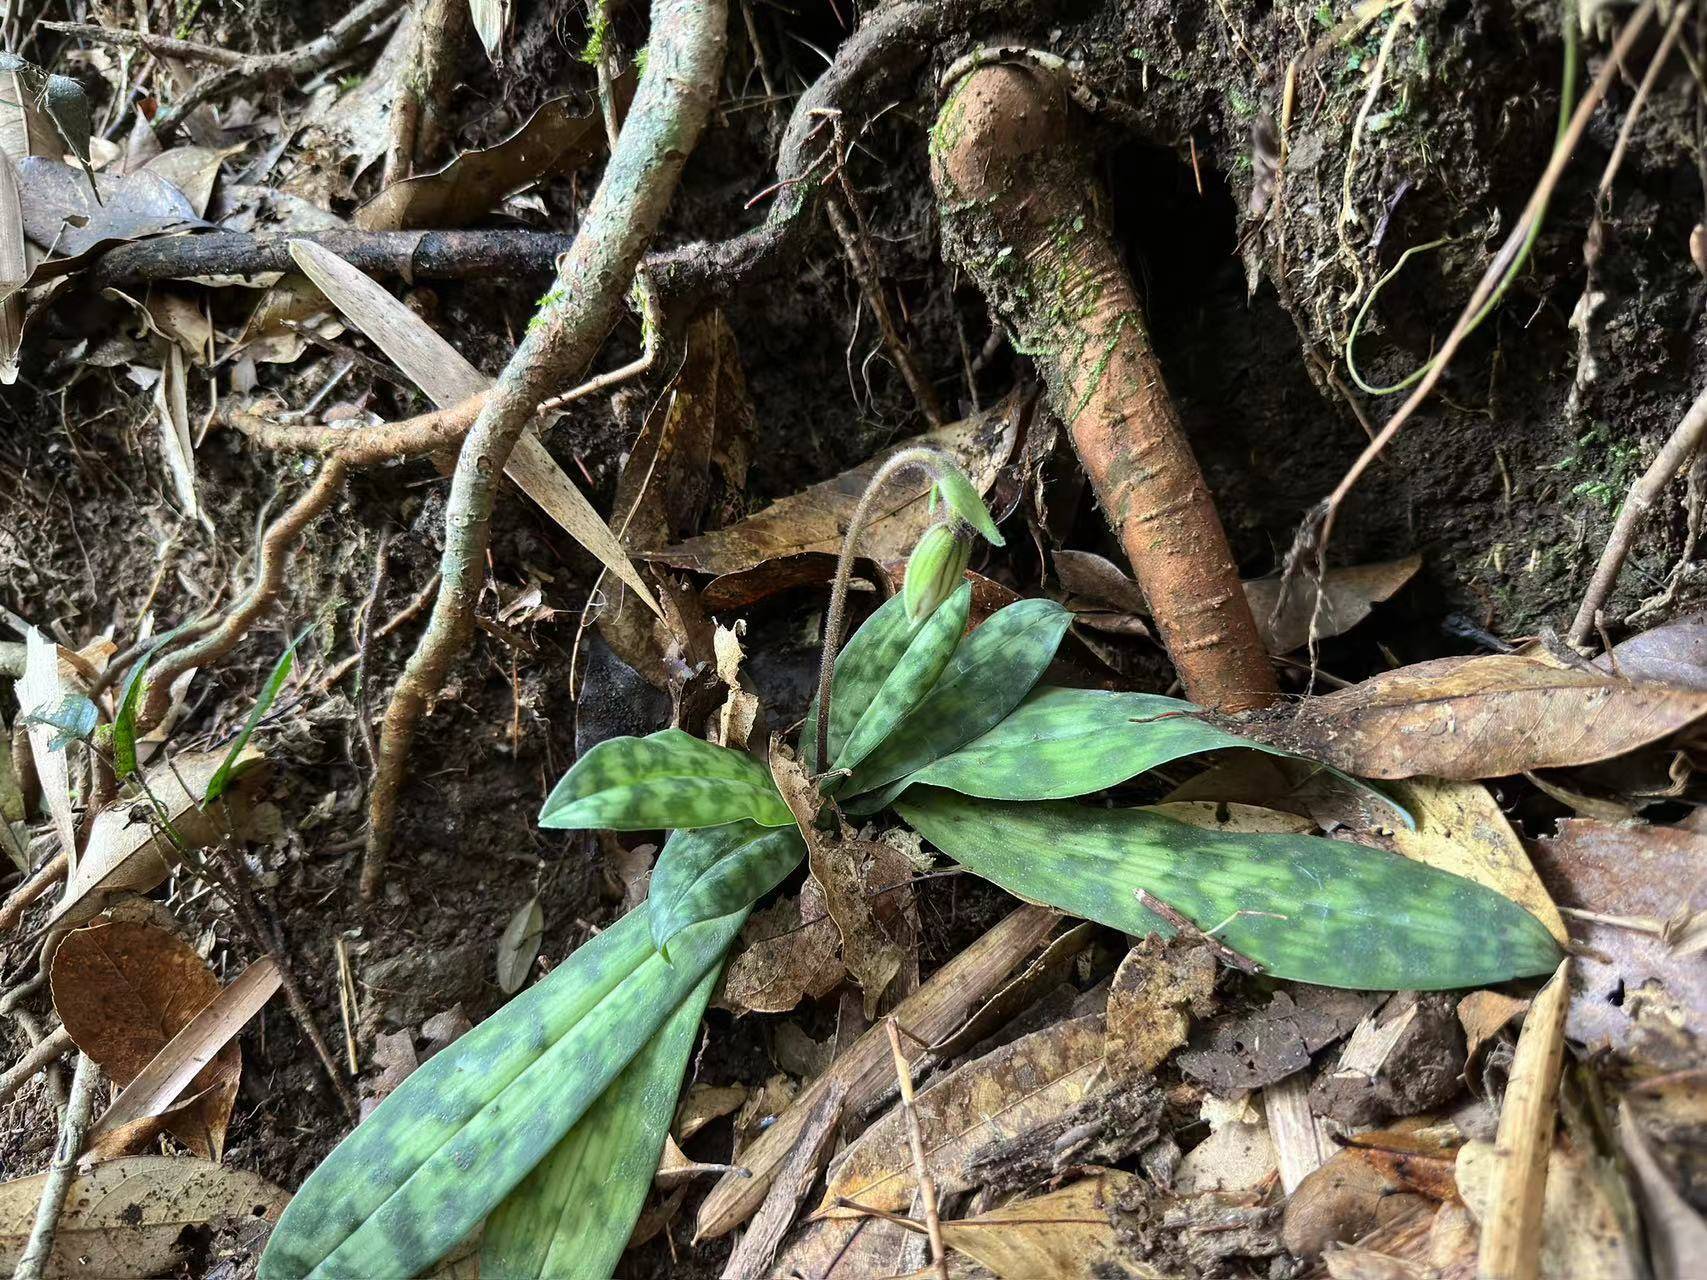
<box><xmin>362</xmin><ymin>0</ymin><xmax>727</xmax><ymax>898</ymax></box>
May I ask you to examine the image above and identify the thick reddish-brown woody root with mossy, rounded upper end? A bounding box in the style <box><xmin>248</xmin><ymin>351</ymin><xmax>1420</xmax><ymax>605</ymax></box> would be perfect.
<box><xmin>930</xmin><ymin>65</ymin><xmax>1277</xmax><ymax>712</ymax></box>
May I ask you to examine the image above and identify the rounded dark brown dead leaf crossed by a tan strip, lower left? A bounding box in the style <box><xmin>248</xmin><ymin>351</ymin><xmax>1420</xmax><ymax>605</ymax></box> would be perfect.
<box><xmin>50</xmin><ymin>923</ymin><xmax>248</xmax><ymax>1161</ymax></box>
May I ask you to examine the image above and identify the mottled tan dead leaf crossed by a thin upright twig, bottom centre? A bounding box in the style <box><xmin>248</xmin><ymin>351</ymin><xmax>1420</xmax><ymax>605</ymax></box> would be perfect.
<box><xmin>816</xmin><ymin>1015</ymin><xmax>1104</xmax><ymax>1217</ymax></box>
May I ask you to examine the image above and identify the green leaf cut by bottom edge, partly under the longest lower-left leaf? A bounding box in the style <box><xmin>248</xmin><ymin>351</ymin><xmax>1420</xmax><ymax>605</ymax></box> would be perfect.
<box><xmin>480</xmin><ymin>966</ymin><xmax>722</xmax><ymax>1280</ymax></box>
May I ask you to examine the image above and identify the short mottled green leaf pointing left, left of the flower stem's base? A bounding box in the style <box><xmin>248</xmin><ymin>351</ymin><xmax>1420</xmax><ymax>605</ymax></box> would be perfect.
<box><xmin>539</xmin><ymin>729</ymin><xmax>794</xmax><ymax>831</ymax></box>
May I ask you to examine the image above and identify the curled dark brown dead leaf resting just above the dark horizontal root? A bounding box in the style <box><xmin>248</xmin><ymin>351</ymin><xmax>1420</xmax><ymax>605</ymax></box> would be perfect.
<box><xmin>352</xmin><ymin>89</ymin><xmax>614</xmax><ymax>230</ymax></box>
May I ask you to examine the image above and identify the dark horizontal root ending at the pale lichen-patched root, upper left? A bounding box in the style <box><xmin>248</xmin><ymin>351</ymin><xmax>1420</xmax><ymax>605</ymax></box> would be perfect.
<box><xmin>87</xmin><ymin>230</ymin><xmax>575</xmax><ymax>288</ymax></box>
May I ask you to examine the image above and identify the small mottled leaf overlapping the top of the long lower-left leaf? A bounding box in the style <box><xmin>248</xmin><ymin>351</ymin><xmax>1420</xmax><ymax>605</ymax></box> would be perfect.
<box><xmin>647</xmin><ymin>823</ymin><xmax>806</xmax><ymax>951</ymax></box>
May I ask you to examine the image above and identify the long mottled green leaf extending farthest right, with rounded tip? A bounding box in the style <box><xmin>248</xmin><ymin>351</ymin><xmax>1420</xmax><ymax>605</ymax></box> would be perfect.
<box><xmin>894</xmin><ymin>787</ymin><xmax>1558</xmax><ymax>990</ymax></box>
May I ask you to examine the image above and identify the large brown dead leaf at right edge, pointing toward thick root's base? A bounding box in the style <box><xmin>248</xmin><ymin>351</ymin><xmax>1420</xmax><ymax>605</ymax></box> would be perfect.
<box><xmin>1243</xmin><ymin>654</ymin><xmax>1707</xmax><ymax>780</ymax></box>
